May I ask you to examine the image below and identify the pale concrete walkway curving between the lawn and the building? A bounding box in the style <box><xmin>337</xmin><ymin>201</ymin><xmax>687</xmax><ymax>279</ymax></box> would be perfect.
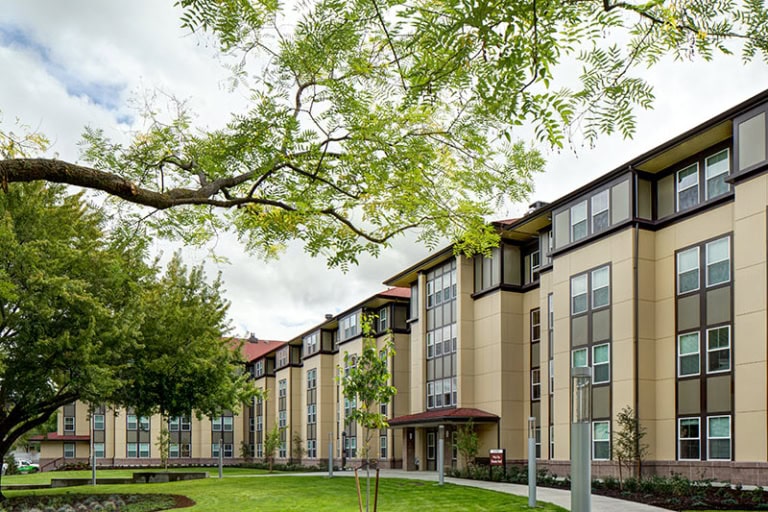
<box><xmin>242</xmin><ymin>469</ymin><xmax>667</xmax><ymax>512</ymax></box>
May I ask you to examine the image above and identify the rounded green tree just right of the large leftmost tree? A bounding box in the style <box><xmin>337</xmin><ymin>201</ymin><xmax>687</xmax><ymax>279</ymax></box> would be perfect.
<box><xmin>109</xmin><ymin>253</ymin><xmax>256</xmax><ymax>468</ymax></box>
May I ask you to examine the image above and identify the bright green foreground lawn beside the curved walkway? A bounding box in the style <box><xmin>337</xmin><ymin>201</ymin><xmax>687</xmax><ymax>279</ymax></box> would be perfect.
<box><xmin>0</xmin><ymin>472</ymin><xmax>564</xmax><ymax>512</ymax></box>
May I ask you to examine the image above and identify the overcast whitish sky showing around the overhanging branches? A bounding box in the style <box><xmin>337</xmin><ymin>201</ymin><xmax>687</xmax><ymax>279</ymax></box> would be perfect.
<box><xmin>0</xmin><ymin>0</ymin><xmax>768</xmax><ymax>339</ymax></box>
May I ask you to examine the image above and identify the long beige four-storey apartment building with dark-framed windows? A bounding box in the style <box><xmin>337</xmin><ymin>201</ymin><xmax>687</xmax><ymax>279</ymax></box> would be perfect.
<box><xmin>39</xmin><ymin>91</ymin><xmax>768</xmax><ymax>485</ymax></box>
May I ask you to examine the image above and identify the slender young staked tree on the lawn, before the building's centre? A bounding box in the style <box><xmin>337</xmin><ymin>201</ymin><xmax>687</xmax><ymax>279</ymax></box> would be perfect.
<box><xmin>341</xmin><ymin>315</ymin><xmax>397</xmax><ymax>512</ymax></box>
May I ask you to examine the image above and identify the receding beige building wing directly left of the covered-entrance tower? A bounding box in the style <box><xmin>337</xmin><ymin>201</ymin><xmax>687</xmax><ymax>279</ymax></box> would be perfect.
<box><xmin>254</xmin><ymin>288</ymin><xmax>410</xmax><ymax>467</ymax></box>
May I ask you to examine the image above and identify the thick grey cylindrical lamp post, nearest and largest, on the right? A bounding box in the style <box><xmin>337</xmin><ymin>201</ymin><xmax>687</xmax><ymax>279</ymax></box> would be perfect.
<box><xmin>571</xmin><ymin>367</ymin><xmax>592</xmax><ymax>512</ymax></box>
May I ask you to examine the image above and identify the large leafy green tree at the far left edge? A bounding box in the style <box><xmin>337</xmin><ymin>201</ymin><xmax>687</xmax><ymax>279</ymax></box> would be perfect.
<box><xmin>0</xmin><ymin>183</ymin><xmax>249</xmax><ymax>498</ymax></box>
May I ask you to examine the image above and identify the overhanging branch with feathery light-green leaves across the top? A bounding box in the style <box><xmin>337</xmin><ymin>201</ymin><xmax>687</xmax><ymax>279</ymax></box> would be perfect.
<box><xmin>0</xmin><ymin>0</ymin><xmax>768</xmax><ymax>265</ymax></box>
